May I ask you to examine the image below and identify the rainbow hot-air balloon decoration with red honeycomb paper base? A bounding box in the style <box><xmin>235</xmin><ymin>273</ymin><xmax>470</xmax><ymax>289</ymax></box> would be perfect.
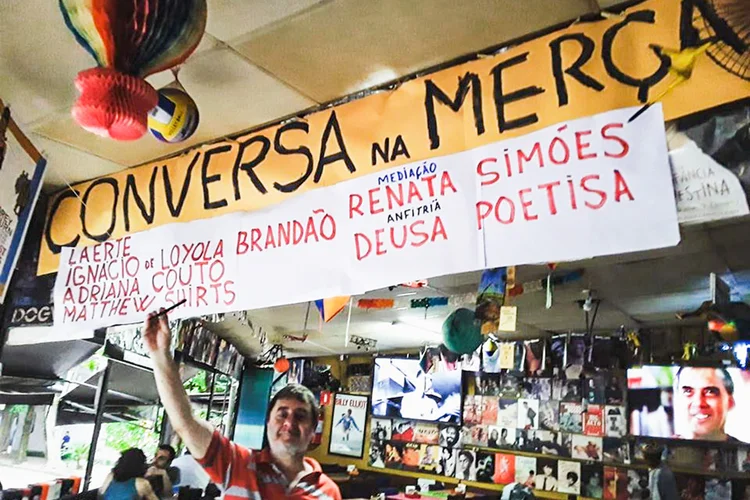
<box><xmin>59</xmin><ymin>0</ymin><xmax>207</xmax><ymax>141</ymax></box>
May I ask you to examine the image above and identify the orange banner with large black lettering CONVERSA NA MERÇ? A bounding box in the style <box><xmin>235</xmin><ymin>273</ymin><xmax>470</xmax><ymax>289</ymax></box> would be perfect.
<box><xmin>39</xmin><ymin>0</ymin><xmax>750</xmax><ymax>274</ymax></box>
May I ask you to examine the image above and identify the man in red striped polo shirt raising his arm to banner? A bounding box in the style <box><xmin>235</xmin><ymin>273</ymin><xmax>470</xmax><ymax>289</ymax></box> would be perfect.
<box><xmin>144</xmin><ymin>308</ymin><xmax>341</xmax><ymax>500</ymax></box>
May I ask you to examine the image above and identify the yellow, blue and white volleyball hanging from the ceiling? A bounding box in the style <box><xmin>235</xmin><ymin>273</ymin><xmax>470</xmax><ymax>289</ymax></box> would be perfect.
<box><xmin>148</xmin><ymin>87</ymin><xmax>200</xmax><ymax>143</ymax></box>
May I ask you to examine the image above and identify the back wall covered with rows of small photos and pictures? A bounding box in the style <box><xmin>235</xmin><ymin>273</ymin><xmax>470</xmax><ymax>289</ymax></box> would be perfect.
<box><xmin>313</xmin><ymin>335</ymin><xmax>750</xmax><ymax>500</ymax></box>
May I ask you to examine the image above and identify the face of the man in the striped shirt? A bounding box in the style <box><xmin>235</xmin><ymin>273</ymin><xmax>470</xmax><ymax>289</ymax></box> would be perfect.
<box><xmin>266</xmin><ymin>399</ymin><xmax>315</xmax><ymax>455</ymax></box>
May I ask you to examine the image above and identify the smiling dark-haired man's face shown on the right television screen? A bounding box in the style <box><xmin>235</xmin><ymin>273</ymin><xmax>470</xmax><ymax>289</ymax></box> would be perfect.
<box><xmin>675</xmin><ymin>368</ymin><xmax>734</xmax><ymax>439</ymax></box>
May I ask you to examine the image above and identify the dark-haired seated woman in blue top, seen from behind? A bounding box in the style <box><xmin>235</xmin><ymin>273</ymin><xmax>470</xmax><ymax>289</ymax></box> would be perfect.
<box><xmin>99</xmin><ymin>448</ymin><xmax>158</xmax><ymax>500</ymax></box>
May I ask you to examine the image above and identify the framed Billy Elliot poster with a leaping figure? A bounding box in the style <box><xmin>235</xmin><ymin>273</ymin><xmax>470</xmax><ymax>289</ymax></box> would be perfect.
<box><xmin>328</xmin><ymin>394</ymin><xmax>369</xmax><ymax>458</ymax></box>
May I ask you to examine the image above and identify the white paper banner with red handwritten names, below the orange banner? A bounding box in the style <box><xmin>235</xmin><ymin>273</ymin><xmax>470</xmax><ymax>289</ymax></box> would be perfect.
<box><xmin>55</xmin><ymin>106</ymin><xmax>679</xmax><ymax>328</ymax></box>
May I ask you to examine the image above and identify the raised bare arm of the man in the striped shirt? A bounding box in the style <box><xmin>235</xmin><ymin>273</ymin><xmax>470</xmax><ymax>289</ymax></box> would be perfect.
<box><xmin>144</xmin><ymin>313</ymin><xmax>213</xmax><ymax>459</ymax></box>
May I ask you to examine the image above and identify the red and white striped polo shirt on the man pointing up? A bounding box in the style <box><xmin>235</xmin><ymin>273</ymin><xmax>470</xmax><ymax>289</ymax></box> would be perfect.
<box><xmin>198</xmin><ymin>432</ymin><xmax>341</xmax><ymax>500</ymax></box>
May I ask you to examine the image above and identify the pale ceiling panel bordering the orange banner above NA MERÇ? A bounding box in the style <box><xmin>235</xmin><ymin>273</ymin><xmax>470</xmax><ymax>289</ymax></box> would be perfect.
<box><xmin>234</xmin><ymin>0</ymin><xmax>593</xmax><ymax>102</ymax></box>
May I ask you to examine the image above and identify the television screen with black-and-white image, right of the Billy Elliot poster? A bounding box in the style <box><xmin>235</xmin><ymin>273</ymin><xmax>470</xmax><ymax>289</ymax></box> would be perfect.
<box><xmin>372</xmin><ymin>358</ymin><xmax>461</xmax><ymax>423</ymax></box>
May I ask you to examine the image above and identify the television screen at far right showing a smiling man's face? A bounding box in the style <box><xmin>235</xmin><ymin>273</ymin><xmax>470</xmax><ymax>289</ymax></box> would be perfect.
<box><xmin>628</xmin><ymin>366</ymin><xmax>750</xmax><ymax>443</ymax></box>
